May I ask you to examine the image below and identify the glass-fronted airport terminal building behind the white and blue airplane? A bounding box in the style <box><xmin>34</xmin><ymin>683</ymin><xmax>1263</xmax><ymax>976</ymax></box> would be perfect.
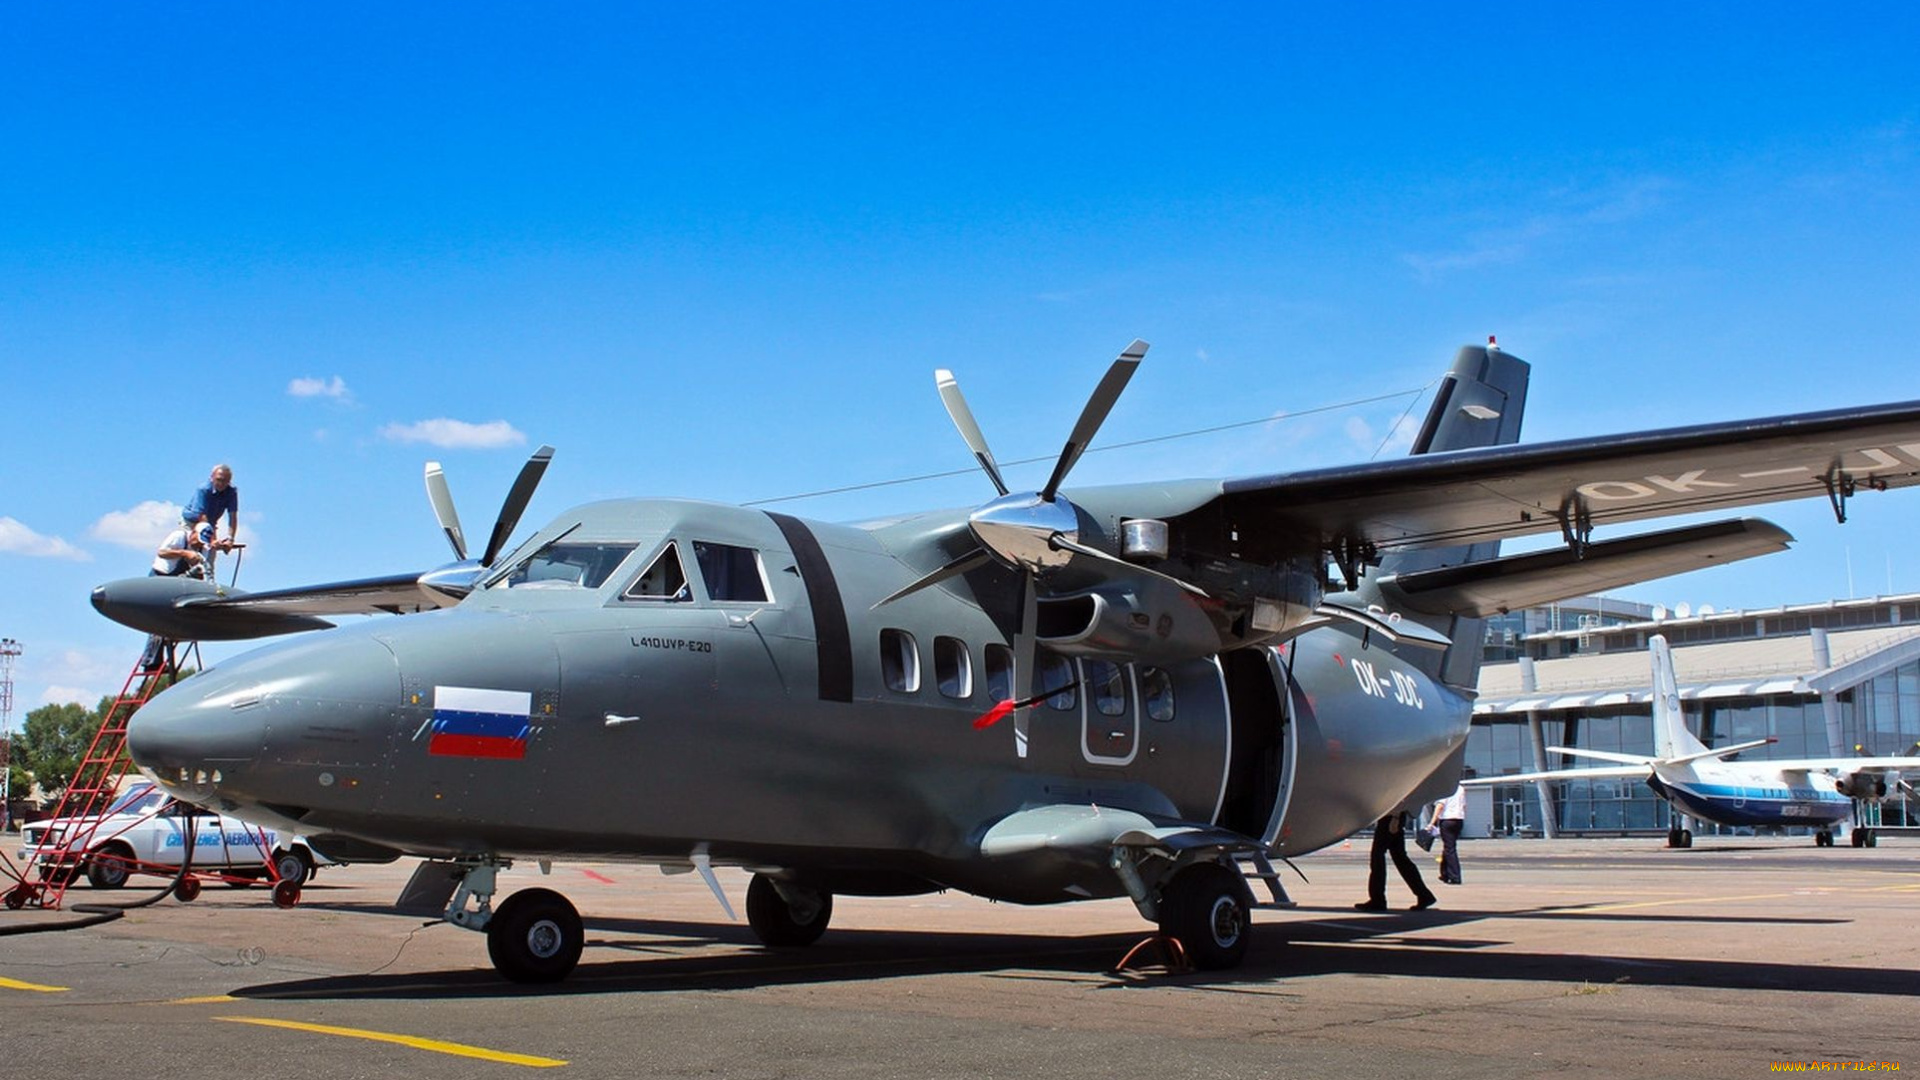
<box><xmin>1467</xmin><ymin>594</ymin><xmax>1920</xmax><ymax>836</ymax></box>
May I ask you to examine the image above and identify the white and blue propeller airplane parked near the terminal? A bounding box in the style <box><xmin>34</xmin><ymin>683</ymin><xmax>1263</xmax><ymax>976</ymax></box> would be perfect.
<box><xmin>1465</xmin><ymin>634</ymin><xmax>1920</xmax><ymax>847</ymax></box>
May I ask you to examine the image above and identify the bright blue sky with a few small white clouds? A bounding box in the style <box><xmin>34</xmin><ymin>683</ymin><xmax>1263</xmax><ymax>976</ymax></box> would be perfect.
<box><xmin>0</xmin><ymin>4</ymin><xmax>1920</xmax><ymax>707</ymax></box>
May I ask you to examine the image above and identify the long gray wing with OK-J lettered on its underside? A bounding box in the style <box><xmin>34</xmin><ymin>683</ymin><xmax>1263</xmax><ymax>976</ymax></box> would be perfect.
<box><xmin>1221</xmin><ymin>402</ymin><xmax>1920</xmax><ymax>552</ymax></box>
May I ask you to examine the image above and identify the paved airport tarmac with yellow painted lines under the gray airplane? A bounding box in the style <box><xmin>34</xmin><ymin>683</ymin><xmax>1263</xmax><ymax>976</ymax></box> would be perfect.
<box><xmin>0</xmin><ymin>836</ymin><xmax>1920</xmax><ymax>1080</ymax></box>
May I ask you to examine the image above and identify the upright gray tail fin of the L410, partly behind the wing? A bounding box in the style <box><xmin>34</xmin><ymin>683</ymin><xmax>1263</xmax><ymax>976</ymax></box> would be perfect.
<box><xmin>1379</xmin><ymin>342</ymin><xmax>1532</xmax><ymax>688</ymax></box>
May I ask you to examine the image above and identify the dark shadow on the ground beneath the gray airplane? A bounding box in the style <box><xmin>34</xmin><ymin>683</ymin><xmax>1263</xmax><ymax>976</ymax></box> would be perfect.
<box><xmin>232</xmin><ymin>905</ymin><xmax>1920</xmax><ymax>1001</ymax></box>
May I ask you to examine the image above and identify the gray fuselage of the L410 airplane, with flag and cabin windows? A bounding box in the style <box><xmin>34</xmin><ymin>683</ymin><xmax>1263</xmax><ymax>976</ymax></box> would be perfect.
<box><xmin>131</xmin><ymin>500</ymin><xmax>1469</xmax><ymax>903</ymax></box>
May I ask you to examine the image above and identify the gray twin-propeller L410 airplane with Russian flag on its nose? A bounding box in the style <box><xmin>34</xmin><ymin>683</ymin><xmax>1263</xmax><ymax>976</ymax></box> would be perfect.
<box><xmin>82</xmin><ymin>342</ymin><xmax>1920</xmax><ymax>982</ymax></box>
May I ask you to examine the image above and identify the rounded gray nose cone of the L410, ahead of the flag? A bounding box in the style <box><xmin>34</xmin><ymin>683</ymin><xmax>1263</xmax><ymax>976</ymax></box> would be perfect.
<box><xmin>127</xmin><ymin>630</ymin><xmax>399</xmax><ymax>801</ymax></box>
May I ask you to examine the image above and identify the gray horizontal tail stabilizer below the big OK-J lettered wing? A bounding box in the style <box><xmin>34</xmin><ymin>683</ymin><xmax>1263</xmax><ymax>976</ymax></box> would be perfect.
<box><xmin>1380</xmin><ymin>517</ymin><xmax>1793</xmax><ymax>619</ymax></box>
